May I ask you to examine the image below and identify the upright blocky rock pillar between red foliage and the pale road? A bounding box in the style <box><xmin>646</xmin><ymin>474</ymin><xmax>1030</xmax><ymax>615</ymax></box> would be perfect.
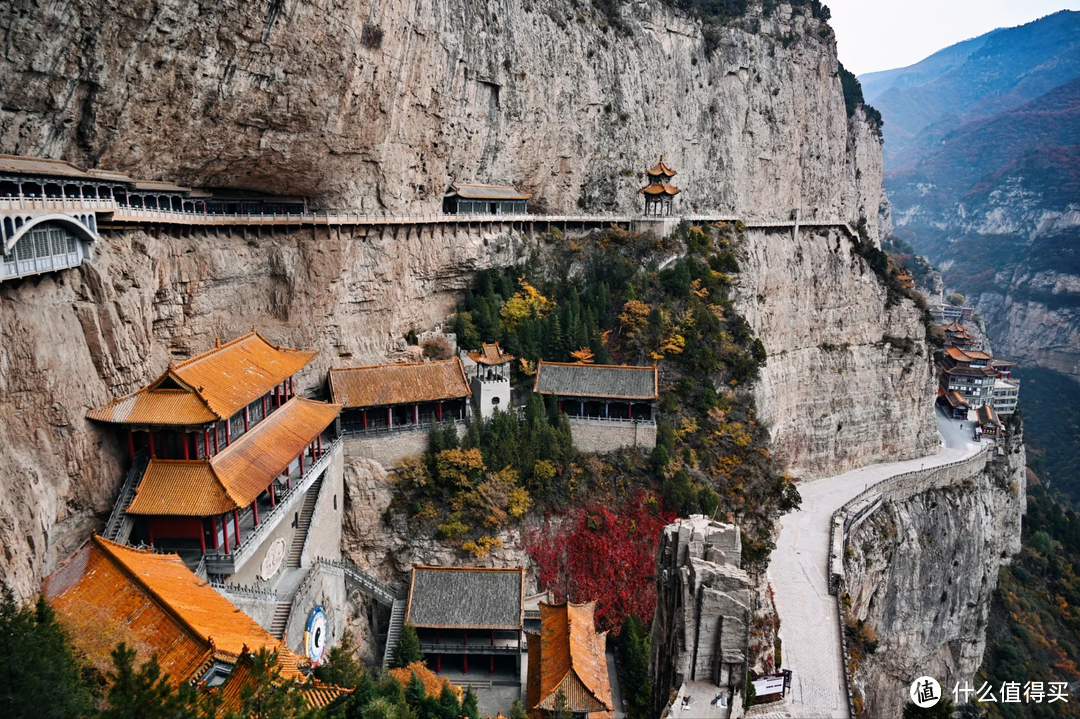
<box><xmin>649</xmin><ymin>515</ymin><xmax>751</xmax><ymax>711</ymax></box>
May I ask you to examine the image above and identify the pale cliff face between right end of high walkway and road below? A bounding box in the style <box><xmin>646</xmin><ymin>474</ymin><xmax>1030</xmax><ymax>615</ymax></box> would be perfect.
<box><xmin>737</xmin><ymin>228</ymin><xmax>939</xmax><ymax>477</ymax></box>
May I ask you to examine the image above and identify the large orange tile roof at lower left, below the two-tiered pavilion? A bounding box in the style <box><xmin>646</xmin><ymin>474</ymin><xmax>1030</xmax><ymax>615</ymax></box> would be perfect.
<box><xmin>43</xmin><ymin>534</ymin><xmax>291</xmax><ymax>682</ymax></box>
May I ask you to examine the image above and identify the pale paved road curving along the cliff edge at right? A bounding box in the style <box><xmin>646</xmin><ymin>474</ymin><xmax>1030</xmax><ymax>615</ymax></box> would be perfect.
<box><xmin>755</xmin><ymin>411</ymin><xmax>980</xmax><ymax>719</ymax></box>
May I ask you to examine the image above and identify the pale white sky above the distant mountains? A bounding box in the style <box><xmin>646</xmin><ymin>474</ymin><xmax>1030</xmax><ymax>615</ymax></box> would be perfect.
<box><xmin>824</xmin><ymin>0</ymin><xmax>1080</xmax><ymax>74</ymax></box>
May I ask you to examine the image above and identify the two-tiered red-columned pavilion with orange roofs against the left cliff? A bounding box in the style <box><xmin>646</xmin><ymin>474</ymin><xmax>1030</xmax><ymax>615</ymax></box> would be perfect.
<box><xmin>87</xmin><ymin>330</ymin><xmax>341</xmax><ymax>575</ymax></box>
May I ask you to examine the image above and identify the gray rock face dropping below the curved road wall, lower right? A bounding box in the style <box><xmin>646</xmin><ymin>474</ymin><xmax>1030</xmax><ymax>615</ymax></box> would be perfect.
<box><xmin>845</xmin><ymin>439</ymin><xmax>1026</xmax><ymax>717</ymax></box>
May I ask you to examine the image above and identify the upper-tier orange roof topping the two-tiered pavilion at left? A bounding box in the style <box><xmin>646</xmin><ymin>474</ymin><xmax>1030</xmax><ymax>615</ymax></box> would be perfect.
<box><xmin>86</xmin><ymin>331</ymin><xmax>315</xmax><ymax>426</ymax></box>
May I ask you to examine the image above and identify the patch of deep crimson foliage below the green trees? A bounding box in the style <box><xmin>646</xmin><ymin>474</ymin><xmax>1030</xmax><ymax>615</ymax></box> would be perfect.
<box><xmin>527</xmin><ymin>494</ymin><xmax>675</xmax><ymax>630</ymax></box>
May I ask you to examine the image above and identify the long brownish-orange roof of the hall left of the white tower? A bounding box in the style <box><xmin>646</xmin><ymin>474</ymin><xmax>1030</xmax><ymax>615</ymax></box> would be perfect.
<box><xmin>330</xmin><ymin>357</ymin><xmax>472</xmax><ymax>407</ymax></box>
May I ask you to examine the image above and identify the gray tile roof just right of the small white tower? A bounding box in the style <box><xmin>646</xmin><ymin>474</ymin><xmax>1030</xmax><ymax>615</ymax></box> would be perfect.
<box><xmin>532</xmin><ymin>362</ymin><xmax>657</xmax><ymax>399</ymax></box>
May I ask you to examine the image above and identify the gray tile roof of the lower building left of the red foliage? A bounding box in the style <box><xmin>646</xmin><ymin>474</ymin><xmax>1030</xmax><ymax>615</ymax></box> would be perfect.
<box><xmin>406</xmin><ymin>567</ymin><xmax>525</xmax><ymax>629</ymax></box>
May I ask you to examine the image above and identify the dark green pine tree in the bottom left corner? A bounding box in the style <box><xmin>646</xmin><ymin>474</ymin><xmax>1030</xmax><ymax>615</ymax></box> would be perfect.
<box><xmin>0</xmin><ymin>589</ymin><xmax>91</xmax><ymax>719</ymax></box>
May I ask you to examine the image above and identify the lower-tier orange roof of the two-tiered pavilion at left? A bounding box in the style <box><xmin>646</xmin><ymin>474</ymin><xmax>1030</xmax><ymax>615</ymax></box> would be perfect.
<box><xmin>127</xmin><ymin>397</ymin><xmax>341</xmax><ymax>517</ymax></box>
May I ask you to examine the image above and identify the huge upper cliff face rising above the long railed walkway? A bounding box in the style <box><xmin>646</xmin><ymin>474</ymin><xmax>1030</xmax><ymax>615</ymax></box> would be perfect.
<box><xmin>0</xmin><ymin>0</ymin><xmax>881</xmax><ymax>229</ymax></box>
